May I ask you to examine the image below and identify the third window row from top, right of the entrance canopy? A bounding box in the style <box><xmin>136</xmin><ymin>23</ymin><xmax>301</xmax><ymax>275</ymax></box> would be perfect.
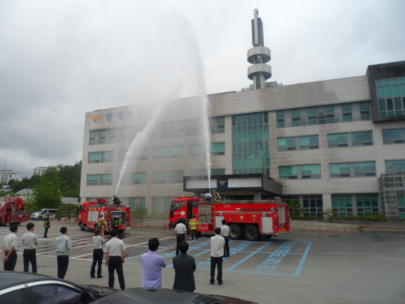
<box><xmin>279</xmin><ymin>160</ymin><xmax>405</xmax><ymax>179</ymax></box>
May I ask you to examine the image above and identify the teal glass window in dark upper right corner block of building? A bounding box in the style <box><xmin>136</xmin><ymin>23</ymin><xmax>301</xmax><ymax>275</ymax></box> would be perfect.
<box><xmin>376</xmin><ymin>77</ymin><xmax>405</xmax><ymax>117</ymax></box>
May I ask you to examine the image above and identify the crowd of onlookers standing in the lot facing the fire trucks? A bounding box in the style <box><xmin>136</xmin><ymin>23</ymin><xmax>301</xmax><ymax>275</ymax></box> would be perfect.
<box><xmin>2</xmin><ymin>217</ymin><xmax>229</xmax><ymax>291</ymax></box>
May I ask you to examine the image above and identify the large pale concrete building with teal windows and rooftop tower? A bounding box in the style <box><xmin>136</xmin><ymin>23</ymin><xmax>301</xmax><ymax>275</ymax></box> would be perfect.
<box><xmin>81</xmin><ymin>10</ymin><xmax>405</xmax><ymax>217</ymax></box>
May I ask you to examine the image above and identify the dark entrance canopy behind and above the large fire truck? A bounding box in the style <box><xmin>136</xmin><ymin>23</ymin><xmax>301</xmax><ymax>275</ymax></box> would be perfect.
<box><xmin>183</xmin><ymin>174</ymin><xmax>283</xmax><ymax>199</ymax></box>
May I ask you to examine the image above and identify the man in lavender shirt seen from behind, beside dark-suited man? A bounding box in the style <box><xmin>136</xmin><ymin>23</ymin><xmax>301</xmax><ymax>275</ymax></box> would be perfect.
<box><xmin>141</xmin><ymin>238</ymin><xmax>166</xmax><ymax>288</ymax></box>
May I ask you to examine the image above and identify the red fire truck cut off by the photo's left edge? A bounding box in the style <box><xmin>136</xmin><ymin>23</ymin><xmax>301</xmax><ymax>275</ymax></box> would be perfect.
<box><xmin>0</xmin><ymin>197</ymin><xmax>30</xmax><ymax>226</ymax></box>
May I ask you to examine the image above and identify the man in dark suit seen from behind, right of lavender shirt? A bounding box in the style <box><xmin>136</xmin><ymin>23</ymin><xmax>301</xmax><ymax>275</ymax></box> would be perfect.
<box><xmin>173</xmin><ymin>241</ymin><xmax>197</xmax><ymax>291</ymax></box>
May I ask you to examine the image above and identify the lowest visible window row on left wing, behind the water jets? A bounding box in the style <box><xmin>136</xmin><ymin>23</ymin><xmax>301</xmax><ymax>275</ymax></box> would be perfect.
<box><xmin>87</xmin><ymin>169</ymin><xmax>225</xmax><ymax>186</ymax></box>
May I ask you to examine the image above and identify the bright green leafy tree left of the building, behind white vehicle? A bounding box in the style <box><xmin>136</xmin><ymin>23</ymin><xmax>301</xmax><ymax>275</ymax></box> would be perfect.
<box><xmin>32</xmin><ymin>168</ymin><xmax>62</xmax><ymax>209</ymax></box>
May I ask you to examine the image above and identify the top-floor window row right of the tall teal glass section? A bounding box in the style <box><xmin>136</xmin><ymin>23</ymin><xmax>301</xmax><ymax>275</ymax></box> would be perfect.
<box><xmin>277</xmin><ymin>101</ymin><xmax>371</xmax><ymax>128</ymax></box>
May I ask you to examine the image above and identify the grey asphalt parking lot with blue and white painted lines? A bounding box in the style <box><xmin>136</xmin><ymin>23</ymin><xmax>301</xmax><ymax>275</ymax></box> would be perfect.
<box><xmin>0</xmin><ymin>221</ymin><xmax>405</xmax><ymax>303</ymax></box>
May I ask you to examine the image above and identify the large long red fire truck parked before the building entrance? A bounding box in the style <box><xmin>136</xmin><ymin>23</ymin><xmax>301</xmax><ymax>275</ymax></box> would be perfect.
<box><xmin>169</xmin><ymin>196</ymin><xmax>291</xmax><ymax>241</ymax></box>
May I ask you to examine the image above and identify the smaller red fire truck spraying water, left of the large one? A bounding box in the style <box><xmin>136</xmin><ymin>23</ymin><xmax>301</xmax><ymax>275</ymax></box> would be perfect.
<box><xmin>79</xmin><ymin>198</ymin><xmax>132</xmax><ymax>233</ymax></box>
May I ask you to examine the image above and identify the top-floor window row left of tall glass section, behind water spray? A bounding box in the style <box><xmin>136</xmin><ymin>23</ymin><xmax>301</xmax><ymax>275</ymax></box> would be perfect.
<box><xmin>89</xmin><ymin>117</ymin><xmax>225</xmax><ymax>145</ymax></box>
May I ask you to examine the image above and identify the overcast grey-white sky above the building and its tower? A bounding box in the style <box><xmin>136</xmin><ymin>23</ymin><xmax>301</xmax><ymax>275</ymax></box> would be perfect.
<box><xmin>0</xmin><ymin>0</ymin><xmax>405</xmax><ymax>176</ymax></box>
